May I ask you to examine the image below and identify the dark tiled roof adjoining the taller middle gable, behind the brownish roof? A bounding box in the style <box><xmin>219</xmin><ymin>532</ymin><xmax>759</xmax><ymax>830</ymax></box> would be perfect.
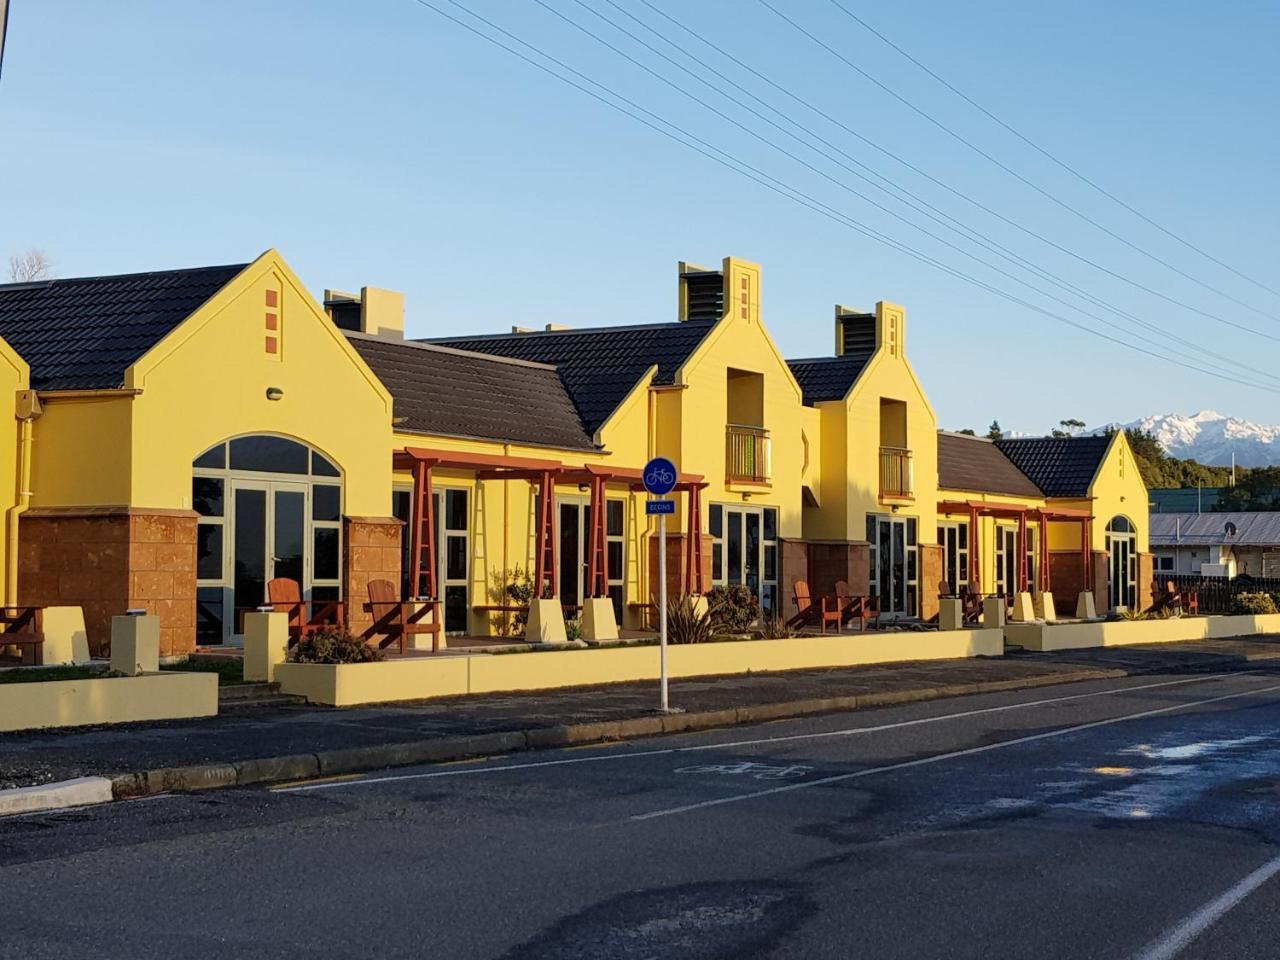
<box><xmin>422</xmin><ymin>320</ymin><xmax>716</xmax><ymax>433</ymax></box>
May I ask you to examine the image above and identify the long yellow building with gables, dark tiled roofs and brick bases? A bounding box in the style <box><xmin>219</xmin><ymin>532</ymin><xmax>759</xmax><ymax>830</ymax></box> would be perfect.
<box><xmin>0</xmin><ymin>251</ymin><xmax>1149</xmax><ymax>654</ymax></box>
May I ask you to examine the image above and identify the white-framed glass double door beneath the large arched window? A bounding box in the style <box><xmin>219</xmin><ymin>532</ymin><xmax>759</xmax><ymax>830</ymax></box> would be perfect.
<box><xmin>229</xmin><ymin>479</ymin><xmax>311</xmax><ymax>634</ymax></box>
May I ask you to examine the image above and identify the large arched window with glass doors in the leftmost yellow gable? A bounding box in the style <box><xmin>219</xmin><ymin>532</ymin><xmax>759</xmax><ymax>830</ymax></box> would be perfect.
<box><xmin>191</xmin><ymin>434</ymin><xmax>343</xmax><ymax>643</ymax></box>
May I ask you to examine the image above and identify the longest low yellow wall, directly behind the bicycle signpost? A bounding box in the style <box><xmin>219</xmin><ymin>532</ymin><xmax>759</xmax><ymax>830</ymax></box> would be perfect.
<box><xmin>275</xmin><ymin>630</ymin><xmax>1005</xmax><ymax>707</ymax></box>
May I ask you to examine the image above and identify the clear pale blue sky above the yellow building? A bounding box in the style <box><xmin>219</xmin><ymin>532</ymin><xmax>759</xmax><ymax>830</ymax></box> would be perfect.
<box><xmin>0</xmin><ymin>0</ymin><xmax>1280</xmax><ymax>431</ymax></box>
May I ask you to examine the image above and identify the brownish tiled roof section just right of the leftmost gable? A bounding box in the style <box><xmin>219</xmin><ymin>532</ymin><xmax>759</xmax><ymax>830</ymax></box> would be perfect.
<box><xmin>347</xmin><ymin>333</ymin><xmax>595</xmax><ymax>449</ymax></box>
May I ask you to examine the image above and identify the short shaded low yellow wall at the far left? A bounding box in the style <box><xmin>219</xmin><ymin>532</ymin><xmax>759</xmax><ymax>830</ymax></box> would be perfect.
<box><xmin>0</xmin><ymin>672</ymin><xmax>218</xmax><ymax>731</ymax></box>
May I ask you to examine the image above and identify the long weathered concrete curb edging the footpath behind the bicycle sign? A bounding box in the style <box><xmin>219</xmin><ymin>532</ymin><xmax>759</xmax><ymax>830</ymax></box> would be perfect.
<box><xmin>106</xmin><ymin>669</ymin><xmax>1133</xmax><ymax>800</ymax></box>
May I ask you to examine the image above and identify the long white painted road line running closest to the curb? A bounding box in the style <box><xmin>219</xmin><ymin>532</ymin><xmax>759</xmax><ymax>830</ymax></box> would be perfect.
<box><xmin>271</xmin><ymin>673</ymin><xmax>1233</xmax><ymax>794</ymax></box>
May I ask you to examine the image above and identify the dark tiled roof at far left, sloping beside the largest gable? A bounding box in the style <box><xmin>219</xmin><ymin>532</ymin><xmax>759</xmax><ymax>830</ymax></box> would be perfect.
<box><xmin>0</xmin><ymin>264</ymin><xmax>247</xmax><ymax>390</ymax></box>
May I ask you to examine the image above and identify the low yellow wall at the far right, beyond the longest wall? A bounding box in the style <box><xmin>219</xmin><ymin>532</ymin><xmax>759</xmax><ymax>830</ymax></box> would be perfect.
<box><xmin>1005</xmin><ymin>613</ymin><xmax>1280</xmax><ymax>650</ymax></box>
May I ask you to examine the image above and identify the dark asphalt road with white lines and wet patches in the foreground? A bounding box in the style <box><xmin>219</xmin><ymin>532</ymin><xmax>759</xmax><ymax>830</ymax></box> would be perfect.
<box><xmin>0</xmin><ymin>672</ymin><xmax>1280</xmax><ymax>960</ymax></box>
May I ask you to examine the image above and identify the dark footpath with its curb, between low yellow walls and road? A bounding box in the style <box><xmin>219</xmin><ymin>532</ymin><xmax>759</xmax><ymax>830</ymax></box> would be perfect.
<box><xmin>0</xmin><ymin>637</ymin><xmax>1280</xmax><ymax>796</ymax></box>
